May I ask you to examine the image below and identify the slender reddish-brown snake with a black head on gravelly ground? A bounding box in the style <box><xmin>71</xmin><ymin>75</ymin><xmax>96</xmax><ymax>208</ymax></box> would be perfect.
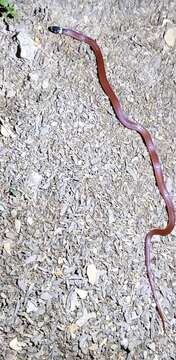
<box><xmin>48</xmin><ymin>25</ymin><xmax>175</xmax><ymax>332</ymax></box>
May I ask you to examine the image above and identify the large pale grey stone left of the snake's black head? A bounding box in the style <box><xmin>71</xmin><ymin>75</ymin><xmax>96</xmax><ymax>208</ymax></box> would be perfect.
<box><xmin>17</xmin><ymin>30</ymin><xmax>37</xmax><ymax>61</ymax></box>
